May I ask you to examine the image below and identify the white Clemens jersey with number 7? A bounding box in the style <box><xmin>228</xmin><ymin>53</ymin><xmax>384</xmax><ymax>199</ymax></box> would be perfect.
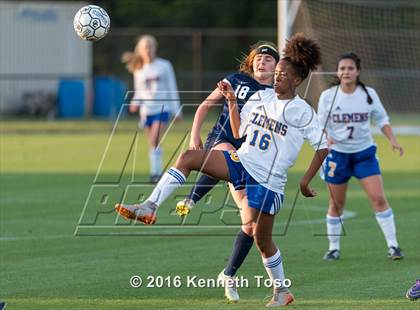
<box><xmin>318</xmin><ymin>86</ymin><xmax>389</xmax><ymax>153</ymax></box>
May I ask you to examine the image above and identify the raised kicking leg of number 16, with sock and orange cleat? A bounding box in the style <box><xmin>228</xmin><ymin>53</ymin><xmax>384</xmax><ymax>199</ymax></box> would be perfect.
<box><xmin>115</xmin><ymin>150</ymin><xmax>229</xmax><ymax>224</ymax></box>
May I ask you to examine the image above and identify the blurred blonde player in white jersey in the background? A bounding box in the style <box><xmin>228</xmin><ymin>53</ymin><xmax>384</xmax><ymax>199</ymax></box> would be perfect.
<box><xmin>123</xmin><ymin>35</ymin><xmax>181</xmax><ymax>183</ymax></box>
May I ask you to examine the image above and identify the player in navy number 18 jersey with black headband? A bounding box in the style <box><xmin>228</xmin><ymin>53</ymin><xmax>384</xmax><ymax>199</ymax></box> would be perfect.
<box><xmin>176</xmin><ymin>41</ymin><xmax>279</xmax><ymax>215</ymax></box>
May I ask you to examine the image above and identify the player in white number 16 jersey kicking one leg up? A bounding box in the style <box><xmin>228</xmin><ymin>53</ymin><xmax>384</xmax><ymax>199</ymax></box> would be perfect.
<box><xmin>115</xmin><ymin>33</ymin><xmax>328</xmax><ymax>307</ymax></box>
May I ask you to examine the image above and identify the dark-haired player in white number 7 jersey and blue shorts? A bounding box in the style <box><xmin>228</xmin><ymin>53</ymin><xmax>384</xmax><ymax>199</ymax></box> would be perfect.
<box><xmin>318</xmin><ymin>52</ymin><xmax>403</xmax><ymax>260</ymax></box>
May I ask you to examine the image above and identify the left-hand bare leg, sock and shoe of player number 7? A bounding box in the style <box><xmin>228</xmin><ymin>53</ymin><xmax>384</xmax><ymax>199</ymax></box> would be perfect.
<box><xmin>324</xmin><ymin>183</ymin><xmax>347</xmax><ymax>261</ymax></box>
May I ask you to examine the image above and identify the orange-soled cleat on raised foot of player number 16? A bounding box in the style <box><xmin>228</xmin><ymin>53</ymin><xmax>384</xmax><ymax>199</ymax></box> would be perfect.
<box><xmin>115</xmin><ymin>200</ymin><xmax>158</xmax><ymax>224</ymax></box>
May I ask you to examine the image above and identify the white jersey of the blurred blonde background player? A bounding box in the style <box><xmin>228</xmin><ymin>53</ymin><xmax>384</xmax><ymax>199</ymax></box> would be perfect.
<box><xmin>133</xmin><ymin>58</ymin><xmax>179</xmax><ymax>115</ymax></box>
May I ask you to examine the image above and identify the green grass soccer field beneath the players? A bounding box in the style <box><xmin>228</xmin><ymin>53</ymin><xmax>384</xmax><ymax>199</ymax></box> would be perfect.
<box><xmin>0</xmin><ymin>122</ymin><xmax>420</xmax><ymax>309</ymax></box>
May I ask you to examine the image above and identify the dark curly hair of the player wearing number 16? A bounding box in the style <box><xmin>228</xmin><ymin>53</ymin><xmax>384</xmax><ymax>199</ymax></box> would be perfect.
<box><xmin>283</xmin><ymin>32</ymin><xmax>321</xmax><ymax>80</ymax></box>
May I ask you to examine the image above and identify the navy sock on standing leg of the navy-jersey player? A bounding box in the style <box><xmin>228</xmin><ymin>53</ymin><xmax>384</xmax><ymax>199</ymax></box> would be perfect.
<box><xmin>225</xmin><ymin>230</ymin><xmax>254</xmax><ymax>277</ymax></box>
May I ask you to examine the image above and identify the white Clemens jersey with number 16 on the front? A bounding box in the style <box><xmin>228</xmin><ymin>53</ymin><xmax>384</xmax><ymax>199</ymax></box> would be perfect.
<box><xmin>237</xmin><ymin>89</ymin><xmax>327</xmax><ymax>194</ymax></box>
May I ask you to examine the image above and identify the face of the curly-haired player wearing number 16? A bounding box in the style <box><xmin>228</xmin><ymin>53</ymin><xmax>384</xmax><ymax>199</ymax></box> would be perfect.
<box><xmin>274</xmin><ymin>59</ymin><xmax>301</xmax><ymax>95</ymax></box>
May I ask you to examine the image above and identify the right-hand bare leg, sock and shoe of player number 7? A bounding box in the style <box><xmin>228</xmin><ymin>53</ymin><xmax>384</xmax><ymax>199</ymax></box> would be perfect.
<box><xmin>360</xmin><ymin>175</ymin><xmax>404</xmax><ymax>260</ymax></box>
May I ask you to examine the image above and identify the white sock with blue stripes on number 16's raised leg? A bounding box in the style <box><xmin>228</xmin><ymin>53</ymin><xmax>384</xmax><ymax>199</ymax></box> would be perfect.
<box><xmin>147</xmin><ymin>167</ymin><xmax>186</xmax><ymax>206</ymax></box>
